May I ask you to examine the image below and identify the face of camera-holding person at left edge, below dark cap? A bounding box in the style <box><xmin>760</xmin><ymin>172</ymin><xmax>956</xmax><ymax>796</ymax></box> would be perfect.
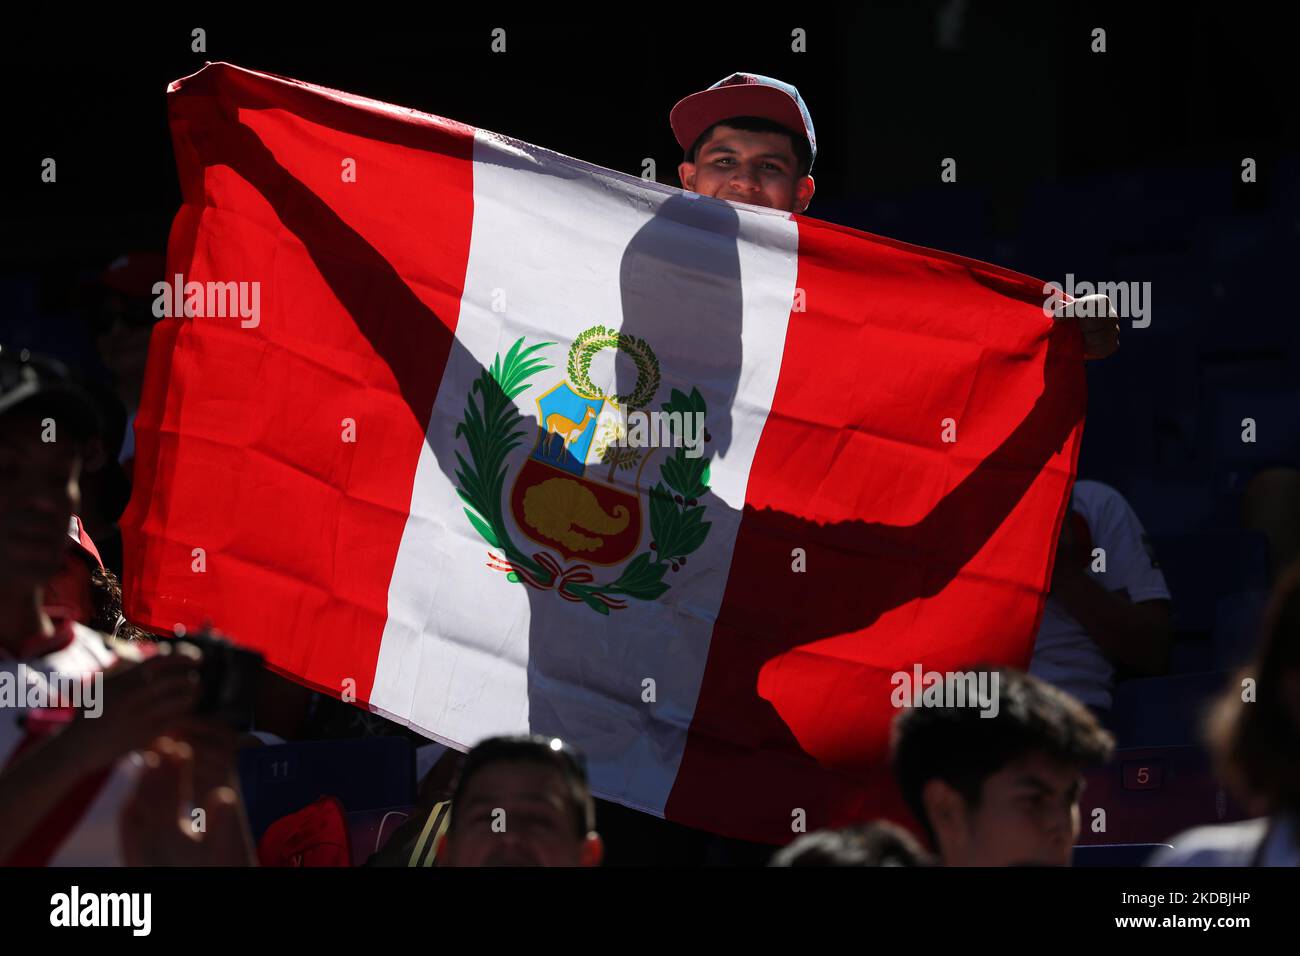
<box><xmin>0</xmin><ymin>415</ymin><xmax>82</xmax><ymax>587</ymax></box>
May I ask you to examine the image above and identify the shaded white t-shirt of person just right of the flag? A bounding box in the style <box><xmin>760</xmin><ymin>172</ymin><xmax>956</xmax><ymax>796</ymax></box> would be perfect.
<box><xmin>1030</xmin><ymin>481</ymin><xmax>1169</xmax><ymax>710</ymax></box>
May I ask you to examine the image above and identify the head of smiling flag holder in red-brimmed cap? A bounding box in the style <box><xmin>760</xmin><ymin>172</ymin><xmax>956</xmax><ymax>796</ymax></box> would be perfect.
<box><xmin>668</xmin><ymin>73</ymin><xmax>816</xmax><ymax>212</ymax></box>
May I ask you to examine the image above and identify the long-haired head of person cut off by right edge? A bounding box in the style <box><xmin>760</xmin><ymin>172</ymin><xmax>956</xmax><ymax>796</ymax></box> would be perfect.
<box><xmin>1209</xmin><ymin>562</ymin><xmax>1300</xmax><ymax>817</ymax></box>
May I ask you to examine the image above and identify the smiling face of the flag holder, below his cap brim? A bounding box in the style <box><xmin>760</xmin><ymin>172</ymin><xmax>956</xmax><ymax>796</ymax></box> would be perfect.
<box><xmin>677</xmin><ymin>125</ymin><xmax>814</xmax><ymax>212</ymax></box>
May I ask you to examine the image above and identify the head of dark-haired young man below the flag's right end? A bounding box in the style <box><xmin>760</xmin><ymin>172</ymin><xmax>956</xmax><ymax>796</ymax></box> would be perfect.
<box><xmin>893</xmin><ymin>670</ymin><xmax>1114</xmax><ymax>866</ymax></box>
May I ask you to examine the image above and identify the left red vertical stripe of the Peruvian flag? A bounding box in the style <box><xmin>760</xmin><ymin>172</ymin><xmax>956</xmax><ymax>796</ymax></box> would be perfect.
<box><xmin>122</xmin><ymin>64</ymin><xmax>473</xmax><ymax>701</ymax></box>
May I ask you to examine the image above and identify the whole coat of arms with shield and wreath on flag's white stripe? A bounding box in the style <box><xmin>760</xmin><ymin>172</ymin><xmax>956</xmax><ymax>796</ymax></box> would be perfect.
<box><xmin>456</xmin><ymin>325</ymin><xmax>710</xmax><ymax>614</ymax></box>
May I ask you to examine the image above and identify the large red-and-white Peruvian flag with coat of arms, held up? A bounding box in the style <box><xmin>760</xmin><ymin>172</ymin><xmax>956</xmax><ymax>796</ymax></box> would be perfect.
<box><xmin>124</xmin><ymin>64</ymin><xmax>1084</xmax><ymax>843</ymax></box>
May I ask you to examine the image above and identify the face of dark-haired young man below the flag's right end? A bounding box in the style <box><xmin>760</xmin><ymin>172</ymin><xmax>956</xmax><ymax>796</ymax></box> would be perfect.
<box><xmin>927</xmin><ymin>754</ymin><xmax>1083</xmax><ymax>866</ymax></box>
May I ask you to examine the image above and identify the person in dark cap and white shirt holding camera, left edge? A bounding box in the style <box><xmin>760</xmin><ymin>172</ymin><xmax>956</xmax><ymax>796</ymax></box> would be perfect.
<box><xmin>0</xmin><ymin>347</ymin><xmax>245</xmax><ymax>865</ymax></box>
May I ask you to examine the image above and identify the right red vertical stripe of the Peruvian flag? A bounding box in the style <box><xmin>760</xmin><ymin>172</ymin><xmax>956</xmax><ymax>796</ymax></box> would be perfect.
<box><xmin>666</xmin><ymin>219</ymin><xmax>1084</xmax><ymax>843</ymax></box>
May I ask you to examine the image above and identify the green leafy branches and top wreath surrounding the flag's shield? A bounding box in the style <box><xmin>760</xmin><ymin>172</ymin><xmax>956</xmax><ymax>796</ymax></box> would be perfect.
<box><xmin>455</xmin><ymin>325</ymin><xmax>711</xmax><ymax>614</ymax></box>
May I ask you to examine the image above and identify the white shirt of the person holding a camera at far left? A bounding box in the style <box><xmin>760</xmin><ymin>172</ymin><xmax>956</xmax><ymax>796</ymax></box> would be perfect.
<box><xmin>0</xmin><ymin>623</ymin><xmax>142</xmax><ymax>866</ymax></box>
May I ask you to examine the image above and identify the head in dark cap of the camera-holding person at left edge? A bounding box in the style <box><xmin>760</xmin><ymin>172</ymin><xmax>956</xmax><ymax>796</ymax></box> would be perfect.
<box><xmin>0</xmin><ymin>346</ymin><xmax>98</xmax><ymax>608</ymax></box>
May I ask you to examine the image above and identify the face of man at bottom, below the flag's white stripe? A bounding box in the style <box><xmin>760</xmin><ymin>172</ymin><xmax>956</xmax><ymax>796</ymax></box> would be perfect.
<box><xmin>438</xmin><ymin>761</ymin><xmax>601</xmax><ymax>866</ymax></box>
